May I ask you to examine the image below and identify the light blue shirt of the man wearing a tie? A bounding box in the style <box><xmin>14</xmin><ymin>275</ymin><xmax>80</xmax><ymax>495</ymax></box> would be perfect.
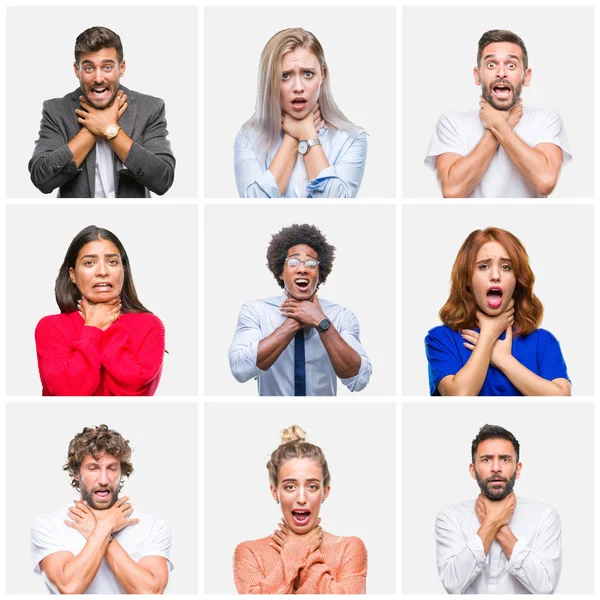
<box><xmin>229</xmin><ymin>293</ymin><xmax>371</xmax><ymax>396</ymax></box>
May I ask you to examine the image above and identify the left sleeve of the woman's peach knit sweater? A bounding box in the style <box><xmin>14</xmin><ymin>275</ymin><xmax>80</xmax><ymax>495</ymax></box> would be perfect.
<box><xmin>233</xmin><ymin>538</ymin><xmax>309</xmax><ymax>594</ymax></box>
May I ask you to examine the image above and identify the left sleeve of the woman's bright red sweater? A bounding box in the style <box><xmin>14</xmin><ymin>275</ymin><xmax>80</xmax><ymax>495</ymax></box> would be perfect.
<box><xmin>35</xmin><ymin>317</ymin><xmax>102</xmax><ymax>396</ymax></box>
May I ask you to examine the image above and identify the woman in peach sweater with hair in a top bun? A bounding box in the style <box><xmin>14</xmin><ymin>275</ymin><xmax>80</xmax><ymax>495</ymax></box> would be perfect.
<box><xmin>233</xmin><ymin>425</ymin><xmax>367</xmax><ymax>594</ymax></box>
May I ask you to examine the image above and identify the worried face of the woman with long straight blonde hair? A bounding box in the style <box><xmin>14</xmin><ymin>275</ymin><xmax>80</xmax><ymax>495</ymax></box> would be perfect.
<box><xmin>279</xmin><ymin>48</ymin><xmax>323</xmax><ymax>119</ymax></box>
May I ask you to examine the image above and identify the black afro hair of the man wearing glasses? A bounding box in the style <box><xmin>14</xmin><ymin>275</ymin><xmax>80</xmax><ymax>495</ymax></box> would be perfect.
<box><xmin>267</xmin><ymin>223</ymin><xmax>335</xmax><ymax>288</ymax></box>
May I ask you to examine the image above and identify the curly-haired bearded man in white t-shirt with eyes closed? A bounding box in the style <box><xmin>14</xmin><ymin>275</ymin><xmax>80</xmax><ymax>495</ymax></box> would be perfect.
<box><xmin>31</xmin><ymin>425</ymin><xmax>173</xmax><ymax>594</ymax></box>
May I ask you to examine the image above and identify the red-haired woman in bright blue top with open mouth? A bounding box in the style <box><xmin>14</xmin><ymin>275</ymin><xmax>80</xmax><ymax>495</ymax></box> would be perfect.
<box><xmin>425</xmin><ymin>227</ymin><xmax>571</xmax><ymax>396</ymax></box>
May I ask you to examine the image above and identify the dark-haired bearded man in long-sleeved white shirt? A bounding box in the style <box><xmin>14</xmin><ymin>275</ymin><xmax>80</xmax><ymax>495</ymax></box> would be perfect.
<box><xmin>435</xmin><ymin>425</ymin><xmax>561</xmax><ymax>594</ymax></box>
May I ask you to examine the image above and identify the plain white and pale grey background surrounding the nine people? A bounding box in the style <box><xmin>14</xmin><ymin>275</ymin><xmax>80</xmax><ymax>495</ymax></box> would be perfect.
<box><xmin>0</xmin><ymin>0</ymin><xmax>600</xmax><ymax>598</ymax></box>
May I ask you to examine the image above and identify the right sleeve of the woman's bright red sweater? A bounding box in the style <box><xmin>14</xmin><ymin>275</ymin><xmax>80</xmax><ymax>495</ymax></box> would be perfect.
<box><xmin>101</xmin><ymin>313</ymin><xmax>165</xmax><ymax>396</ymax></box>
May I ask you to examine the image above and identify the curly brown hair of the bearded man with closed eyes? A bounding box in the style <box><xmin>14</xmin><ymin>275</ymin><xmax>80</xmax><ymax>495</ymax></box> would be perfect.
<box><xmin>63</xmin><ymin>425</ymin><xmax>133</xmax><ymax>490</ymax></box>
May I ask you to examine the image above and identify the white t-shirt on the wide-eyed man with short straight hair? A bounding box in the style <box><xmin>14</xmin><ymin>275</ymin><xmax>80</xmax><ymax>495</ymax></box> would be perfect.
<box><xmin>425</xmin><ymin>107</ymin><xmax>572</xmax><ymax>198</ymax></box>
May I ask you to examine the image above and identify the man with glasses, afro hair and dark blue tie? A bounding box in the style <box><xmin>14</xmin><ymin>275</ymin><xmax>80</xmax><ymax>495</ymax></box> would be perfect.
<box><xmin>229</xmin><ymin>224</ymin><xmax>371</xmax><ymax>396</ymax></box>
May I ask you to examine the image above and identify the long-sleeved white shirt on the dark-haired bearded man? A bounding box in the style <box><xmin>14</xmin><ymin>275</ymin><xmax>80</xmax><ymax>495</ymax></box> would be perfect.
<box><xmin>435</xmin><ymin>498</ymin><xmax>561</xmax><ymax>594</ymax></box>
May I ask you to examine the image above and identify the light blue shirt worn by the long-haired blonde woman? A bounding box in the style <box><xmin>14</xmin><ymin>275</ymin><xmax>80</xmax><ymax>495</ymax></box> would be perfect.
<box><xmin>234</xmin><ymin>125</ymin><xmax>367</xmax><ymax>198</ymax></box>
